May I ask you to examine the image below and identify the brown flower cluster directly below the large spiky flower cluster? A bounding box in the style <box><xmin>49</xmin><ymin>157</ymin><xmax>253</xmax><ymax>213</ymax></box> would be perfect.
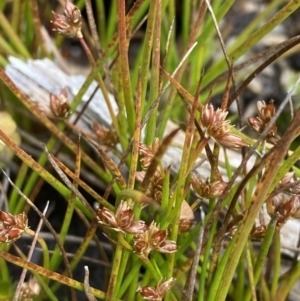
<box><xmin>192</xmin><ymin>175</ymin><xmax>227</xmax><ymax>199</ymax></box>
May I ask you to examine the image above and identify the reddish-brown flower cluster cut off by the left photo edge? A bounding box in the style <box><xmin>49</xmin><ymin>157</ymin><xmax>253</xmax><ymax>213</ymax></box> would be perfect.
<box><xmin>0</xmin><ymin>211</ymin><xmax>28</xmax><ymax>243</ymax></box>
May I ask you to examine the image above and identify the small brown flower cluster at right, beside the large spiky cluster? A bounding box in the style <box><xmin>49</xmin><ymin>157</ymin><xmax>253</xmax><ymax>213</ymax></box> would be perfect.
<box><xmin>248</xmin><ymin>100</ymin><xmax>279</xmax><ymax>144</ymax></box>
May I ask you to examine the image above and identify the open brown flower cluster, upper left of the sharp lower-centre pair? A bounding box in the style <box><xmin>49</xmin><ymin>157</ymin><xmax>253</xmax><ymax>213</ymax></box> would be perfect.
<box><xmin>97</xmin><ymin>202</ymin><xmax>148</xmax><ymax>234</ymax></box>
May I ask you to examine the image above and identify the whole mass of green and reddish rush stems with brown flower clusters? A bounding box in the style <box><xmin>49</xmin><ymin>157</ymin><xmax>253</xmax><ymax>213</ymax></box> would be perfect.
<box><xmin>0</xmin><ymin>0</ymin><xmax>300</xmax><ymax>301</ymax></box>
